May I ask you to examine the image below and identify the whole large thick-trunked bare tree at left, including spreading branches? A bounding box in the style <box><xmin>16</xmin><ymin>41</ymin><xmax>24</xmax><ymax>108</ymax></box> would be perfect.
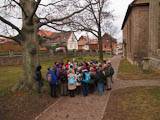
<box><xmin>0</xmin><ymin>0</ymin><xmax>94</xmax><ymax>90</ymax></box>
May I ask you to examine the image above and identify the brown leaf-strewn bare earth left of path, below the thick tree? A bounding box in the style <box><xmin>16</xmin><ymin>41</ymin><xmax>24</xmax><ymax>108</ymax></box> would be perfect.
<box><xmin>0</xmin><ymin>91</ymin><xmax>57</xmax><ymax>120</ymax></box>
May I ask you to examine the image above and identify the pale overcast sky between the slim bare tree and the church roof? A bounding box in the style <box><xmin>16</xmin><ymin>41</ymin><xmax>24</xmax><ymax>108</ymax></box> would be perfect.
<box><xmin>0</xmin><ymin>0</ymin><xmax>133</xmax><ymax>41</ymax></box>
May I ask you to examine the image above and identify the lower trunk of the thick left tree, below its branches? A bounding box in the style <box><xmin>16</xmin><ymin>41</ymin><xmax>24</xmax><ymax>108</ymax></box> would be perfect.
<box><xmin>22</xmin><ymin>30</ymin><xmax>40</xmax><ymax>90</ymax></box>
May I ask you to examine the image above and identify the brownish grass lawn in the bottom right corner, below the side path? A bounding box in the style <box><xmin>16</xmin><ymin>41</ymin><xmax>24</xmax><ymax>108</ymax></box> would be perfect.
<box><xmin>103</xmin><ymin>87</ymin><xmax>160</xmax><ymax>120</ymax></box>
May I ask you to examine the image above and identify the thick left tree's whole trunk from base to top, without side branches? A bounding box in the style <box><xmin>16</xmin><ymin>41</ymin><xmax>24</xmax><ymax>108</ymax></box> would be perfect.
<box><xmin>15</xmin><ymin>0</ymin><xmax>40</xmax><ymax>90</ymax></box>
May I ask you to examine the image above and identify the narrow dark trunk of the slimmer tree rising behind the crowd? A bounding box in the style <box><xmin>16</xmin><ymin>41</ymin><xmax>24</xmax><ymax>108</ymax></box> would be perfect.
<box><xmin>98</xmin><ymin>36</ymin><xmax>103</xmax><ymax>64</ymax></box>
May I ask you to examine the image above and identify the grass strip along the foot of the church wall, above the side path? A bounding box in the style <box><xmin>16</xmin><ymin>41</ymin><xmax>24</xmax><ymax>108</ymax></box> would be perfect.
<box><xmin>118</xmin><ymin>59</ymin><xmax>160</xmax><ymax>80</ymax></box>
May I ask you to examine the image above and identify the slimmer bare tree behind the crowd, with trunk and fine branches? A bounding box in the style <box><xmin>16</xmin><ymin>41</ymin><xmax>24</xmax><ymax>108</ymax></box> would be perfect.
<box><xmin>50</xmin><ymin>0</ymin><xmax>113</xmax><ymax>63</ymax></box>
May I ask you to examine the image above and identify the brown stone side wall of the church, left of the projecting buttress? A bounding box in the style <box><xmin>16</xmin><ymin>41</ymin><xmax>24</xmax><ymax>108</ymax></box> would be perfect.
<box><xmin>123</xmin><ymin>6</ymin><xmax>149</xmax><ymax>64</ymax></box>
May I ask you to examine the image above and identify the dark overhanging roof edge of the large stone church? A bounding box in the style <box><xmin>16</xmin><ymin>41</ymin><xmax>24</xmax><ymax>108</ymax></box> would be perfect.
<box><xmin>121</xmin><ymin>0</ymin><xmax>149</xmax><ymax>30</ymax></box>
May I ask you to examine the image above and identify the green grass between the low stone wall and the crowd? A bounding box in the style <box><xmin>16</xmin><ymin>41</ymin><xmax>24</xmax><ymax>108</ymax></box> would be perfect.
<box><xmin>0</xmin><ymin>56</ymin><xmax>112</xmax><ymax>92</ymax></box>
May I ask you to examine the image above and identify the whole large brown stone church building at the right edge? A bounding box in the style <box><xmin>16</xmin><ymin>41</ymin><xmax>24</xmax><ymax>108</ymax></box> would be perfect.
<box><xmin>122</xmin><ymin>0</ymin><xmax>160</xmax><ymax>69</ymax></box>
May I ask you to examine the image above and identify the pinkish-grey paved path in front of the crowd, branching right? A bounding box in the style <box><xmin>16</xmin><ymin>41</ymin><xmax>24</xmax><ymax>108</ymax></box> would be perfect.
<box><xmin>36</xmin><ymin>56</ymin><xmax>160</xmax><ymax>120</ymax></box>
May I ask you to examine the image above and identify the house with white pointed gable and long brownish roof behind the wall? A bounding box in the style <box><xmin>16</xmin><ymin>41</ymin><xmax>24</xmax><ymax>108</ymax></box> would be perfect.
<box><xmin>39</xmin><ymin>30</ymin><xmax>78</xmax><ymax>50</ymax></box>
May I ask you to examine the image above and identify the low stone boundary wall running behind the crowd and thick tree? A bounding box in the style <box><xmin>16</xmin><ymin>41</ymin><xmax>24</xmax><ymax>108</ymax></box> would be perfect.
<box><xmin>0</xmin><ymin>51</ymin><xmax>98</xmax><ymax>66</ymax></box>
